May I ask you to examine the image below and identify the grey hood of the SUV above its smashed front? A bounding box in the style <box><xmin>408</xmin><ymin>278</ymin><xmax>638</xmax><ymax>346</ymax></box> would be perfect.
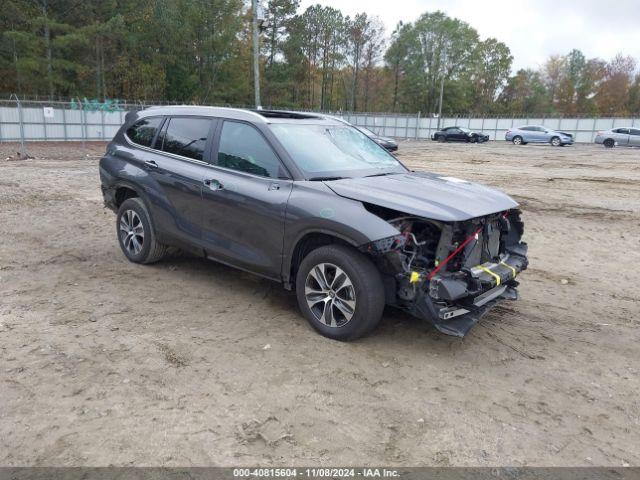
<box><xmin>324</xmin><ymin>172</ymin><xmax>518</xmax><ymax>222</ymax></box>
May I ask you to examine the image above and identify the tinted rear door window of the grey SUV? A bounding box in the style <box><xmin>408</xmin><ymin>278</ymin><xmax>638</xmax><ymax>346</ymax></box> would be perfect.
<box><xmin>157</xmin><ymin>117</ymin><xmax>211</xmax><ymax>160</ymax></box>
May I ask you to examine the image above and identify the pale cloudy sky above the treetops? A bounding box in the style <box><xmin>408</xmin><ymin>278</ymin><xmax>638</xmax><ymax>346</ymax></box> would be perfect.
<box><xmin>301</xmin><ymin>0</ymin><xmax>640</xmax><ymax>70</ymax></box>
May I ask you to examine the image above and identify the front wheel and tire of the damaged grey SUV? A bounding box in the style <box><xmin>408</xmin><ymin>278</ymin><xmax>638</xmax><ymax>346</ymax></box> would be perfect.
<box><xmin>296</xmin><ymin>245</ymin><xmax>385</xmax><ymax>340</ymax></box>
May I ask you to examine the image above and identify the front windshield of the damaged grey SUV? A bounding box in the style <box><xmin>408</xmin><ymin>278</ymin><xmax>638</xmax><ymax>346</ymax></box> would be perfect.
<box><xmin>271</xmin><ymin>123</ymin><xmax>407</xmax><ymax>179</ymax></box>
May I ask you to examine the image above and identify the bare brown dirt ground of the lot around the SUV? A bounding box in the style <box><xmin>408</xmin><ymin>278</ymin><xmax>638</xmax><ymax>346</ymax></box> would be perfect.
<box><xmin>0</xmin><ymin>141</ymin><xmax>640</xmax><ymax>466</ymax></box>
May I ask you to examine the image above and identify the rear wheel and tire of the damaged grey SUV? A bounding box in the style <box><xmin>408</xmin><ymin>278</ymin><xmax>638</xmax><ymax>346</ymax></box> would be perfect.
<box><xmin>116</xmin><ymin>197</ymin><xmax>167</xmax><ymax>264</ymax></box>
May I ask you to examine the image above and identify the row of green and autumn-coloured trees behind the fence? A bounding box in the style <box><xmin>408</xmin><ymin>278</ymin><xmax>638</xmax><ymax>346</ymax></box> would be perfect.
<box><xmin>0</xmin><ymin>0</ymin><xmax>640</xmax><ymax>115</ymax></box>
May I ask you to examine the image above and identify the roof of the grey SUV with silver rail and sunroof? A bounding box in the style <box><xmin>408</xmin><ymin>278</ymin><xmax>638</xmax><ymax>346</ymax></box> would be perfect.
<box><xmin>137</xmin><ymin>105</ymin><xmax>348</xmax><ymax>125</ymax></box>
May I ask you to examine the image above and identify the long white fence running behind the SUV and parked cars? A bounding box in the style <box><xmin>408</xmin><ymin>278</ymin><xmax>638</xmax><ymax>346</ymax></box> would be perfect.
<box><xmin>0</xmin><ymin>100</ymin><xmax>640</xmax><ymax>143</ymax></box>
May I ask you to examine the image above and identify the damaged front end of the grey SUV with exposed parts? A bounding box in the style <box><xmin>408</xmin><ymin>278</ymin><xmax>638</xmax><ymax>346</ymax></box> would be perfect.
<box><xmin>362</xmin><ymin>205</ymin><xmax>528</xmax><ymax>337</ymax></box>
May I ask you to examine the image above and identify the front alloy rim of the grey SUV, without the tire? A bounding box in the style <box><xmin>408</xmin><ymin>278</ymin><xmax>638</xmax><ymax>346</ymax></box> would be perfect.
<box><xmin>304</xmin><ymin>263</ymin><xmax>356</xmax><ymax>328</ymax></box>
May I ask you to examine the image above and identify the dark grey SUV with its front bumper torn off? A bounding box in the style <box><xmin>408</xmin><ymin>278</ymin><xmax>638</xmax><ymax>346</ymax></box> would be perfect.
<box><xmin>100</xmin><ymin>106</ymin><xmax>527</xmax><ymax>340</ymax></box>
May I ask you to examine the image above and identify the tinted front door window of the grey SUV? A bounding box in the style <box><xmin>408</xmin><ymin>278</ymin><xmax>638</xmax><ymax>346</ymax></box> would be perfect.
<box><xmin>217</xmin><ymin>122</ymin><xmax>284</xmax><ymax>178</ymax></box>
